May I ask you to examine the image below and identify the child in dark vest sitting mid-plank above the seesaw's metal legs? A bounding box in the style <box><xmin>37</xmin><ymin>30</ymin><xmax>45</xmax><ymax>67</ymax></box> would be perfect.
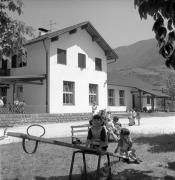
<box><xmin>86</xmin><ymin>114</ymin><xmax>108</xmax><ymax>151</ymax></box>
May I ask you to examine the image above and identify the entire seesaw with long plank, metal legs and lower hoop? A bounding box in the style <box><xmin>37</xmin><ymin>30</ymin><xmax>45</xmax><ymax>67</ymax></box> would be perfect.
<box><xmin>7</xmin><ymin>132</ymin><xmax>124</xmax><ymax>180</ymax></box>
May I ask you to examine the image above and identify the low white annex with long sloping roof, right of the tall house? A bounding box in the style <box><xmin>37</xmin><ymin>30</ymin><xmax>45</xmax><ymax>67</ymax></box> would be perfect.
<box><xmin>108</xmin><ymin>71</ymin><xmax>169</xmax><ymax>112</ymax></box>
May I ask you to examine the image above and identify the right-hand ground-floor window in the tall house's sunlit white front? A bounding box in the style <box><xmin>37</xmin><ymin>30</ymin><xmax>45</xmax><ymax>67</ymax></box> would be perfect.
<box><xmin>89</xmin><ymin>84</ymin><xmax>98</xmax><ymax>105</ymax></box>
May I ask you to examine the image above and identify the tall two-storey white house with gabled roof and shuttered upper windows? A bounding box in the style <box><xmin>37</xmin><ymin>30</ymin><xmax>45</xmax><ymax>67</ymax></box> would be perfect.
<box><xmin>0</xmin><ymin>22</ymin><xmax>118</xmax><ymax>113</ymax></box>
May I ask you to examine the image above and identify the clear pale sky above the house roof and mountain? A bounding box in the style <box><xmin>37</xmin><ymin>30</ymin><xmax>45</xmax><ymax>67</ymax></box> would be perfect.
<box><xmin>13</xmin><ymin>0</ymin><xmax>154</xmax><ymax>48</ymax></box>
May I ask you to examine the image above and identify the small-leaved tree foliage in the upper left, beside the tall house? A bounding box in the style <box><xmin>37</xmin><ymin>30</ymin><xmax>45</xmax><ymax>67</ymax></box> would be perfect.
<box><xmin>0</xmin><ymin>0</ymin><xmax>33</xmax><ymax>59</ymax></box>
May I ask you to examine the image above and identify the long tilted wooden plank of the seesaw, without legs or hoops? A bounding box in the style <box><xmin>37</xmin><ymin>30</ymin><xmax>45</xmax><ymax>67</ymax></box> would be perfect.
<box><xmin>7</xmin><ymin>132</ymin><xmax>123</xmax><ymax>158</ymax></box>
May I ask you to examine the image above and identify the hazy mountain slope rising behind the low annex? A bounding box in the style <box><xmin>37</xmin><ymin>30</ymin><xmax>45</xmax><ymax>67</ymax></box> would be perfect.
<box><xmin>108</xmin><ymin>39</ymin><xmax>175</xmax><ymax>89</ymax></box>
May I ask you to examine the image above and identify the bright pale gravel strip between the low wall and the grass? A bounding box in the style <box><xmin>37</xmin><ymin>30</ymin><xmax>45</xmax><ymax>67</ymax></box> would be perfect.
<box><xmin>0</xmin><ymin>116</ymin><xmax>175</xmax><ymax>144</ymax></box>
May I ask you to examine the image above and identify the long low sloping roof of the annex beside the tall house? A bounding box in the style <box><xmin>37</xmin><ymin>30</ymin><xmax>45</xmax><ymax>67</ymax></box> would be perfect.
<box><xmin>107</xmin><ymin>72</ymin><xmax>169</xmax><ymax>98</ymax></box>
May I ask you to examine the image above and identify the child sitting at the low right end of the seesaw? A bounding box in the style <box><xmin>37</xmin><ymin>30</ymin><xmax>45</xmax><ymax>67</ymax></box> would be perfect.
<box><xmin>114</xmin><ymin>128</ymin><xmax>142</xmax><ymax>164</ymax></box>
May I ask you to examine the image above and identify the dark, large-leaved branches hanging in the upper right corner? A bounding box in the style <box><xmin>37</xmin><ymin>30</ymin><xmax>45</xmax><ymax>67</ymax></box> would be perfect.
<box><xmin>134</xmin><ymin>0</ymin><xmax>175</xmax><ymax>69</ymax></box>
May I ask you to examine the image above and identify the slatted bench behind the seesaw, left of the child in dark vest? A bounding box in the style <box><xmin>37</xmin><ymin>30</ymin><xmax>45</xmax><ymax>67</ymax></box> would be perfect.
<box><xmin>71</xmin><ymin>124</ymin><xmax>90</xmax><ymax>144</ymax></box>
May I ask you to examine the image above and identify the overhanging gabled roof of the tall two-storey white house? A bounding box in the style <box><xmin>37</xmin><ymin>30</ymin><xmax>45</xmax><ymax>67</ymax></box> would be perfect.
<box><xmin>25</xmin><ymin>21</ymin><xmax>118</xmax><ymax>60</ymax></box>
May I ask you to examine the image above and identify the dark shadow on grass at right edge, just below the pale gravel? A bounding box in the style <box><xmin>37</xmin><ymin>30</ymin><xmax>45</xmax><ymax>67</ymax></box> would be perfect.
<box><xmin>134</xmin><ymin>134</ymin><xmax>175</xmax><ymax>153</ymax></box>
